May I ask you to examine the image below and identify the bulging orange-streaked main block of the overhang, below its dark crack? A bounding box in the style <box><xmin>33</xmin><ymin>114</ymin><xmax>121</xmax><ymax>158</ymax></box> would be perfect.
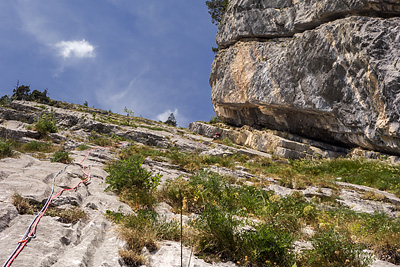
<box><xmin>210</xmin><ymin>14</ymin><xmax>400</xmax><ymax>154</ymax></box>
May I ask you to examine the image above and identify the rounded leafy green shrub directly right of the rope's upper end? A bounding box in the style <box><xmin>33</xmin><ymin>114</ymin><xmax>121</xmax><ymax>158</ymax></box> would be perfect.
<box><xmin>106</xmin><ymin>155</ymin><xmax>162</xmax><ymax>208</ymax></box>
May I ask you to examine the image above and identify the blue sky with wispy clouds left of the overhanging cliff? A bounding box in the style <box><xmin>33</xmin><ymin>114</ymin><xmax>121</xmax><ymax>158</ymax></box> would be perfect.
<box><xmin>0</xmin><ymin>0</ymin><xmax>217</xmax><ymax>127</ymax></box>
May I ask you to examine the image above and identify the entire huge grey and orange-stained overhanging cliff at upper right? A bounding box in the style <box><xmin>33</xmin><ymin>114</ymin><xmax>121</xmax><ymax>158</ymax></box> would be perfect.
<box><xmin>210</xmin><ymin>0</ymin><xmax>400</xmax><ymax>154</ymax></box>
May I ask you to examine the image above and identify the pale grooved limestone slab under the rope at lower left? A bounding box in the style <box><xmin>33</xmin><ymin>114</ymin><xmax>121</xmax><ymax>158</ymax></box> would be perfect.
<box><xmin>0</xmin><ymin>154</ymin><xmax>132</xmax><ymax>267</ymax></box>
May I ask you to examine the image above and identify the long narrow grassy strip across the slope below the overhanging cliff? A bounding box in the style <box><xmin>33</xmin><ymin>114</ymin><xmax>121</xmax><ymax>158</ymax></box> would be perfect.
<box><xmin>120</xmin><ymin>142</ymin><xmax>400</xmax><ymax>196</ymax></box>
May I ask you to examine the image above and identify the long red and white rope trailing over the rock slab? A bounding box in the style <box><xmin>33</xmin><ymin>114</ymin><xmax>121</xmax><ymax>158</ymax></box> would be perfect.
<box><xmin>3</xmin><ymin>147</ymin><xmax>107</xmax><ymax>267</ymax></box>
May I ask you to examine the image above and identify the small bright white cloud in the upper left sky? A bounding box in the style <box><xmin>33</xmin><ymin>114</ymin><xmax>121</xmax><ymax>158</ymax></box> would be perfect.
<box><xmin>55</xmin><ymin>39</ymin><xmax>95</xmax><ymax>58</ymax></box>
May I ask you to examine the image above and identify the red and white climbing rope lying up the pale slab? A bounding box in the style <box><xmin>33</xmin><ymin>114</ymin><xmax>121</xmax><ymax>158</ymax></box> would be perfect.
<box><xmin>3</xmin><ymin>147</ymin><xmax>113</xmax><ymax>267</ymax></box>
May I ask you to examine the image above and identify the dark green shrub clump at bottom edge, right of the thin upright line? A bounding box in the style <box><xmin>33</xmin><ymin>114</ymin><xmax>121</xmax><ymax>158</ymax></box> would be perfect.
<box><xmin>193</xmin><ymin>205</ymin><xmax>294</xmax><ymax>267</ymax></box>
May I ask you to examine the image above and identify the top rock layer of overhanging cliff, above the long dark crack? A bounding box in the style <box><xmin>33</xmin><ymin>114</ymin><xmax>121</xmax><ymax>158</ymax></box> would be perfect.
<box><xmin>217</xmin><ymin>0</ymin><xmax>400</xmax><ymax>47</ymax></box>
